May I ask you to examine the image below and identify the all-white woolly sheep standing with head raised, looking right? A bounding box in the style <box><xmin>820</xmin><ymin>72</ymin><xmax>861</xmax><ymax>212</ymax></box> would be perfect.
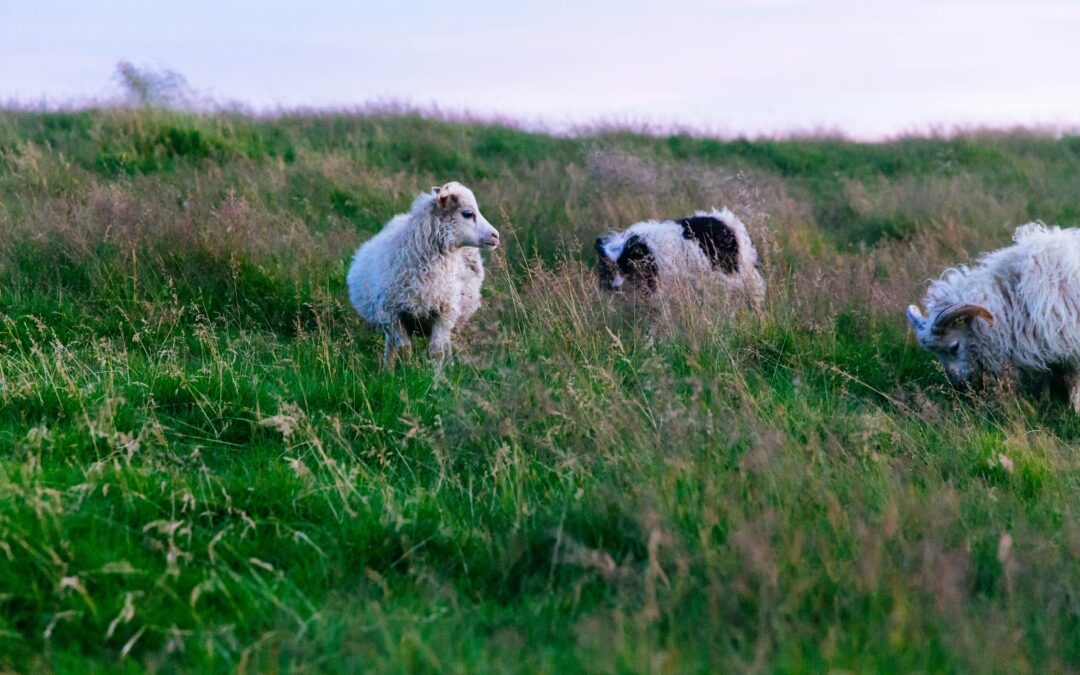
<box><xmin>348</xmin><ymin>183</ymin><xmax>499</xmax><ymax>365</ymax></box>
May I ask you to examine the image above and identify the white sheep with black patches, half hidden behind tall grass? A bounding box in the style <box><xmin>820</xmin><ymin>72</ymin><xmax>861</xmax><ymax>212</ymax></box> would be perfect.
<box><xmin>596</xmin><ymin>208</ymin><xmax>765</xmax><ymax>307</ymax></box>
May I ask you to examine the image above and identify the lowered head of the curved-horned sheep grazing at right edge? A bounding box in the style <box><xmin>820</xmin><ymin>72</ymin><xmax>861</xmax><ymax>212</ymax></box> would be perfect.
<box><xmin>907</xmin><ymin>303</ymin><xmax>994</xmax><ymax>388</ymax></box>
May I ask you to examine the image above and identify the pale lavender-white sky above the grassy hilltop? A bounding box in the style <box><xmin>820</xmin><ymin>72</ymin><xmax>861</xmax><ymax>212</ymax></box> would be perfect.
<box><xmin>0</xmin><ymin>0</ymin><xmax>1080</xmax><ymax>137</ymax></box>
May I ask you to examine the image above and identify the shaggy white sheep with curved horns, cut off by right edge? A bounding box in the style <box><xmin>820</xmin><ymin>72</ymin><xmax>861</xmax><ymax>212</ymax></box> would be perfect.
<box><xmin>907</xmin><ymin>222</ymin><xmax>1080</xmax><ymax>413</ymax></box>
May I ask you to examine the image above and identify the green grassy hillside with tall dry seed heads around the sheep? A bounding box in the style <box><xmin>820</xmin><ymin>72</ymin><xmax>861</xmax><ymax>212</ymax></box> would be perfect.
<box><xmin>0</xmin><ymin>110</ymin><xmax>1080</xmax><ymax>673</ymax></box>
